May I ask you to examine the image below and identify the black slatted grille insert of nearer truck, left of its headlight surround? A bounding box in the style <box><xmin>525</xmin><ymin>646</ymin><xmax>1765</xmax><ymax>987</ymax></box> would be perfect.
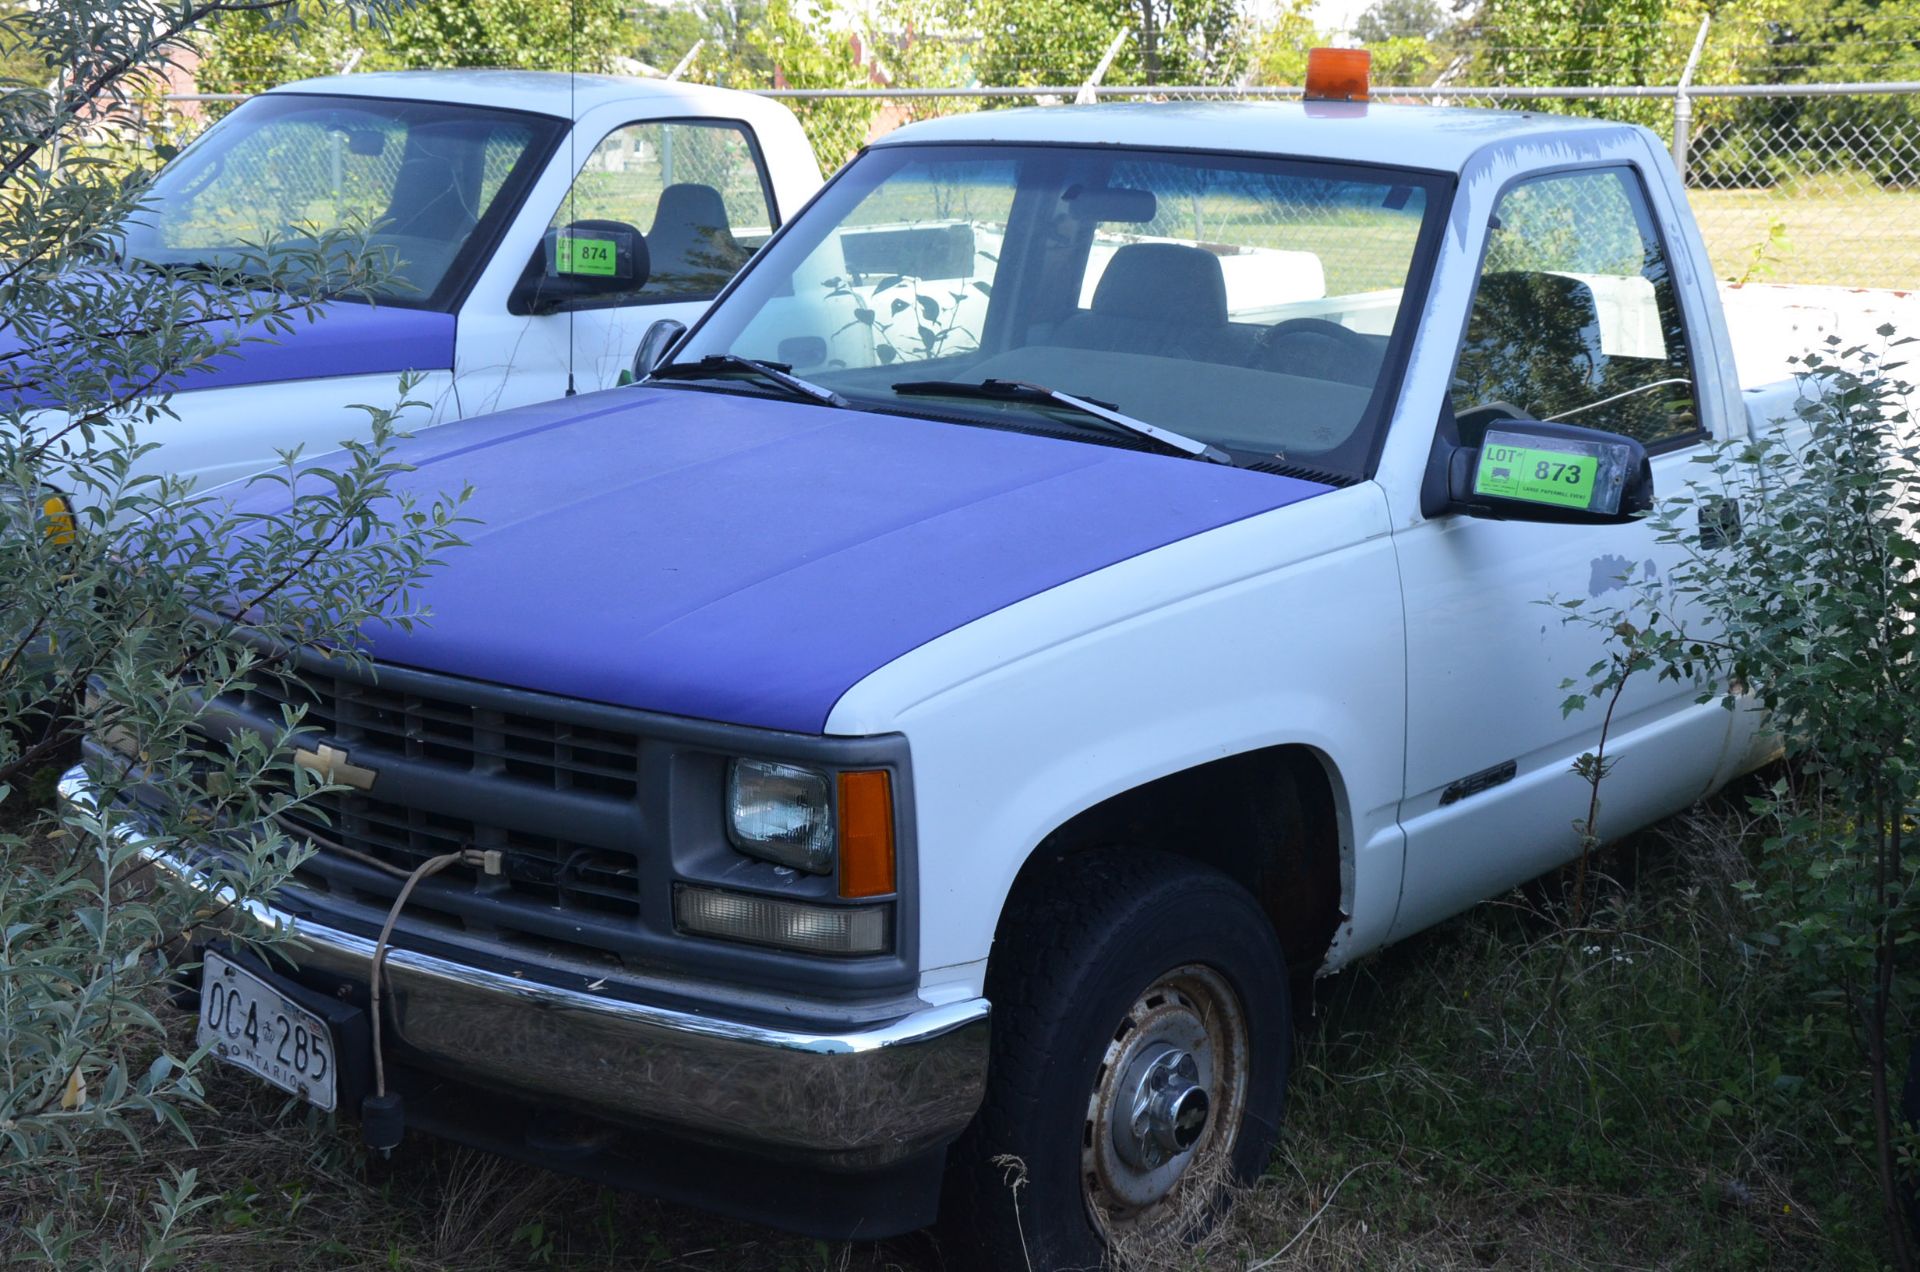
<box><xmin>223</xmin><ymin>659</ymin><xmax>641</xmax><ymax>947</ymax></box>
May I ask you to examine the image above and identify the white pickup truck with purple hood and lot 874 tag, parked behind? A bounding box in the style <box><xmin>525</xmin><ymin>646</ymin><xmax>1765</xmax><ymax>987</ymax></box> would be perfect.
<box><xmin>52</xmin><ymin>71</ymin><xmax>820</xmax><ymax>486</ymax></box>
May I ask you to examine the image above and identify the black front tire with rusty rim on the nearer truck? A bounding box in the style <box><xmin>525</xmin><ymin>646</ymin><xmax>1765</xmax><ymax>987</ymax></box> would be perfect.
<box><xmin>941</xmin><ymin>849</ymin><xmax>1292</xmax><ymax>1272</ymax></box>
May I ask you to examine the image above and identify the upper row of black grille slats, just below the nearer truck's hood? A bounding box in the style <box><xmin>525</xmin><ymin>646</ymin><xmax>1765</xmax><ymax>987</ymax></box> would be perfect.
<box><xmin>242</xmin><ymin>669</ymin><xmax>639</xmax><ymax>799</ymax></box>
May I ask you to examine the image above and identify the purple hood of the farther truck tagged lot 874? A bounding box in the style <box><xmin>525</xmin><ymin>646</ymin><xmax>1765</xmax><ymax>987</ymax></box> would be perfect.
<box><xmin>0</xmin><ymin>300</ymin><xmax>455</xmax><ymax>405</ymax></box>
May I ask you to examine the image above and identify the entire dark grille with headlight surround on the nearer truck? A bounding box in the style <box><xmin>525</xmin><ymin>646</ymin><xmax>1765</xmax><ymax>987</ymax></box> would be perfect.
<box><xmin>165</xmin><ymin>651</ymin><xmax>920</xmax><ymax>991</ymax></box>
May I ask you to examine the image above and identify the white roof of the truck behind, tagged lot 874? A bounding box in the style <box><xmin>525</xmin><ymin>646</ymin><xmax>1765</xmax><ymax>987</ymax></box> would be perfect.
<box><xmin>269</xmin><ymin>69</ymin><xmax>778</xmax><ymax>119</ymax></box>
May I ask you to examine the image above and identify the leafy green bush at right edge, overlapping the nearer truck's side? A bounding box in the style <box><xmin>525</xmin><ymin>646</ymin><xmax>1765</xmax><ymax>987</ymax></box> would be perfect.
<box><xmin>1571</xmin><ymin>327</ymin><xmax>1920</xmax><ymax>1268</ymax></box>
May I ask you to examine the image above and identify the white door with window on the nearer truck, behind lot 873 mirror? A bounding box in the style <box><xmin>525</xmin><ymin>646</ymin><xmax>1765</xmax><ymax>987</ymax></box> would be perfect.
<box><xmin>1394</xmin><ymin>165</ymin><xmax>1732</xmax><ymax>936</ymax></box>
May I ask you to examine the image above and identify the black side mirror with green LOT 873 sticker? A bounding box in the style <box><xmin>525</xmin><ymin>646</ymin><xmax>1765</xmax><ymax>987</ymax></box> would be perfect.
<box><xmin>1434</xmin><ymin>419</ymin><xmax>1653</xmax><ymax>525</ymax></box>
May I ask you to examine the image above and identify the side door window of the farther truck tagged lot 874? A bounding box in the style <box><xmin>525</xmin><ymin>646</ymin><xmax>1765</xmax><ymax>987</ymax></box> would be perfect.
<box><xmin>553</xmin><ymin>123</ymin><xmax>774</xmax><ymax>306</ymax></box>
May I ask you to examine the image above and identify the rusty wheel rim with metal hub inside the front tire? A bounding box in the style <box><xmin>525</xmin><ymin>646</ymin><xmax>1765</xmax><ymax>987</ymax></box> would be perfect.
<box><xmin>1081</xmin><ymin>965</ymin><xmax>1246</xmax><ymax>1234</ymax></box>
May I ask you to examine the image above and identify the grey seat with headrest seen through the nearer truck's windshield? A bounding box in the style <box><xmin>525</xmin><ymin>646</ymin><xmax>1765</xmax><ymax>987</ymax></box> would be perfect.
<box><xmin>1050</xmin><ymin>242</ymin><xmax>1229</xmax><ymax>361</ymax></box>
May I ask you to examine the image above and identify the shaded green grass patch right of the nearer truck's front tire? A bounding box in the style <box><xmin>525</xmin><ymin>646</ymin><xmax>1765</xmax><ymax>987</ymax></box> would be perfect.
<box><xmin>1208</xmin><ymin>815</ymin><xmax>1880</xmax><ymax>1270</ymax></box>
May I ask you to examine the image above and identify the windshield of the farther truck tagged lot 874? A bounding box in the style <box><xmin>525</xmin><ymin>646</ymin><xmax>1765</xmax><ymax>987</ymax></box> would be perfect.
<box><xmin>127</xmin><ymin>94</ymin><xmax>563</xmax><ymax>307</ymax></box>
